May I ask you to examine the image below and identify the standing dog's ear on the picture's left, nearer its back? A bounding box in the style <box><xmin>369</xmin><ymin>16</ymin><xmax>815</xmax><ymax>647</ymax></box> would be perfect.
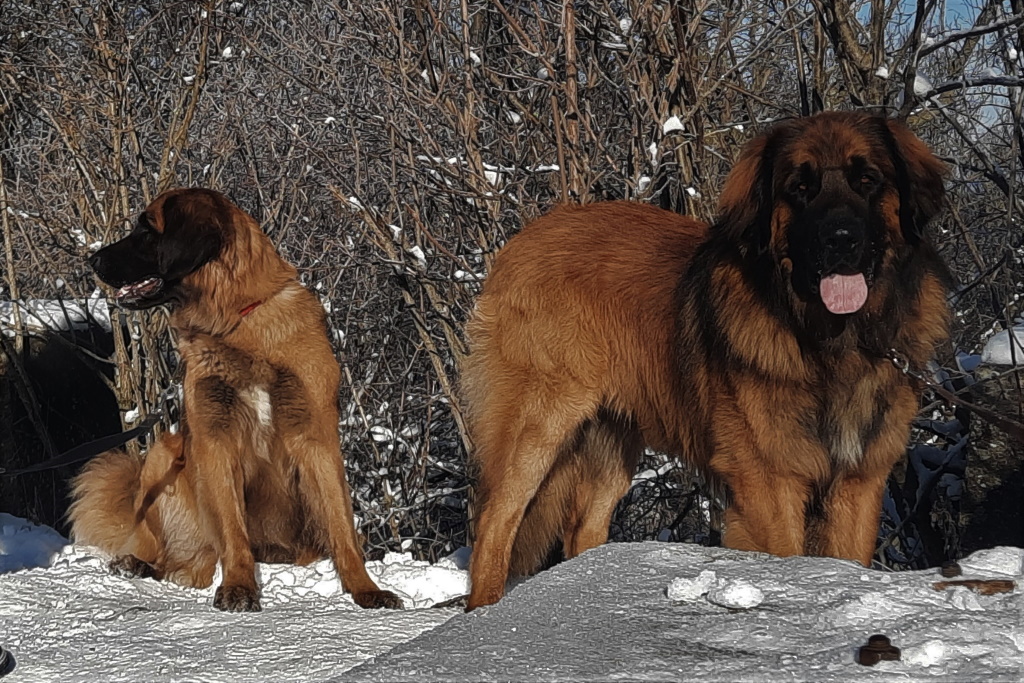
<box><xmin>716</xmin><ymin>123</ymin><xmax>792</xmax><ymax>258</ymax></box>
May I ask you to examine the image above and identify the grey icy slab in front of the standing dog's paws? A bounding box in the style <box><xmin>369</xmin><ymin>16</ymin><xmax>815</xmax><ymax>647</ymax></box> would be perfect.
<box><xmin>352</xmin><ymin>543</ymin><xmax>1024</xmax><ymax>681</ymax></box>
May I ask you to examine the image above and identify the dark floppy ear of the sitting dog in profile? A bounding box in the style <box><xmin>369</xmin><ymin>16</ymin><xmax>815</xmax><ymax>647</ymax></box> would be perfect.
<box><xmin>157</xmin><ymin>190</ymin><xmax>230</xmax><ymax>282</ymax></box>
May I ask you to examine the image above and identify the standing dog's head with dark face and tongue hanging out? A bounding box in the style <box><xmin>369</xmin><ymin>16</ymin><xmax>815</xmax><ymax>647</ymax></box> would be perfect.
<box><xmin>719</xmin><ymin>112</ymin><xmax>944</xmax><ymax>315</ymax></box>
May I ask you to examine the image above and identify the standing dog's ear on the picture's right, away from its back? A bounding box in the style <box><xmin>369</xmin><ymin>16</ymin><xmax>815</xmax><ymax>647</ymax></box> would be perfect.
<box><xmin>882</xmin><ymin>119</ymin><xmax>946</xmax><ymax>245</ymax></box>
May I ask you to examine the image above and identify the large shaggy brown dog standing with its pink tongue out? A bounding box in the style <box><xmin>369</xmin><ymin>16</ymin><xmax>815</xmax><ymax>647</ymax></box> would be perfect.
<box><xmin>462</xmin><ymin>113</ymin><xmax>948</xmax><ymax>608</ymax></box>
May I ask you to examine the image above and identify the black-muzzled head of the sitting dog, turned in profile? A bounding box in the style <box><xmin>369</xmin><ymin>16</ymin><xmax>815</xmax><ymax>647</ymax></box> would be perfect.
<box><xmin>89</xmin><ymin>188</ymin><xmax>237</xmax><ymax>309</ymax></box>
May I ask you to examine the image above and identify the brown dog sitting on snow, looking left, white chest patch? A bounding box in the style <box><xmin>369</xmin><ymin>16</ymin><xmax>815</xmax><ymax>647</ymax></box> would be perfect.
<box><xmin>71</xmin><ymin>189</ymin><xmax>401</xmax><ymax>611</ymax></box>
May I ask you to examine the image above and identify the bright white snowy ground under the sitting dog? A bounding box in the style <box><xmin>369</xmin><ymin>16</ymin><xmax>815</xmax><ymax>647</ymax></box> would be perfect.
<box><xmin>0</xmin><ymin>515</ymin><xmax>468</xmax><ymax>683</ymax></box>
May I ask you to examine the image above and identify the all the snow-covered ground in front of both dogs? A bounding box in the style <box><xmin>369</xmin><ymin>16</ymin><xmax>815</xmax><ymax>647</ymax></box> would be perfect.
<box><xmin>0</xmin><ymin>515</ymin><xmax>1024</xmax><ymax>683</ymax></box>
